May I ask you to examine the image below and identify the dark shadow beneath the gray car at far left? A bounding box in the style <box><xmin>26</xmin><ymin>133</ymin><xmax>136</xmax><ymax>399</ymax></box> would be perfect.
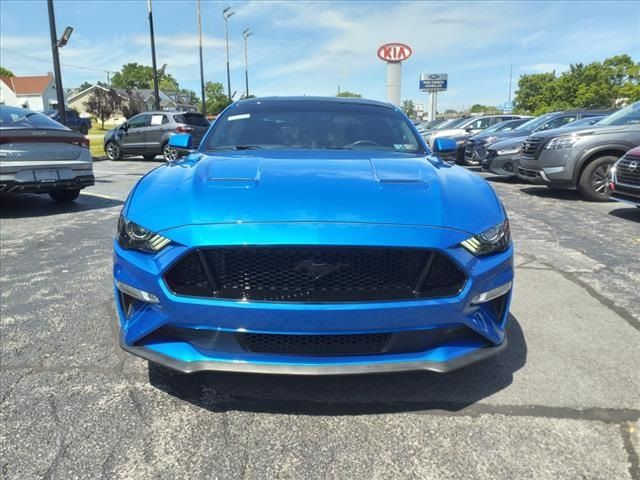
<box><xmin>0</xmin><ymin>193</ymin><xmax>124</xmax><ymax>218</ymax></box>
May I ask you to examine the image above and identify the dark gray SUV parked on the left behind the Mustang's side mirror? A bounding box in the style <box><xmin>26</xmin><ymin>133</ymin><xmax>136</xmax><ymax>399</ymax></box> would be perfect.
<box><xmin>104</xmin><ymin>112</ymin><xmax>209</xmax><ymax>161</ymax></box>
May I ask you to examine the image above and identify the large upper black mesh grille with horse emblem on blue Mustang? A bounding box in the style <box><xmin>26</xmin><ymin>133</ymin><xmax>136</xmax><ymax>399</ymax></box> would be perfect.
<box><xmin>165</xmin><ymin>246</ymin><xmax>465</xmax><ymax>302</ymax></box>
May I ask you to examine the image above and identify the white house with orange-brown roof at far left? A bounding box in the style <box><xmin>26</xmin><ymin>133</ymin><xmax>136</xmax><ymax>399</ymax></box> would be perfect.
<box><xmin>0</xmin><ymin>73</ymin><xmax>58</xmax><ymax>111</ymax></box>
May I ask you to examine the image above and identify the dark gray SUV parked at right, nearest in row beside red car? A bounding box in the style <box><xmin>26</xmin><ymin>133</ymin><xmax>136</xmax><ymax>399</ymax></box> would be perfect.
<box><xmin>518</xmin><ymin>102</ymin><xmax>640</xmax><ymax>201</ymax></box>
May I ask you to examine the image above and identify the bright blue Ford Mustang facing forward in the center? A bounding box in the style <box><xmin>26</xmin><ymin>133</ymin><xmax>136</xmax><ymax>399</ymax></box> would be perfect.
<box><xmin>113</xmin><ymin>97</ymin><xmax>513</xmax><ymax>374</ymax></box>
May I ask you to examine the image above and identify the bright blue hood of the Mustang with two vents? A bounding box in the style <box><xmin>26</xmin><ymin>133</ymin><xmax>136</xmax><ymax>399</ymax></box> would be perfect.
<box><xmin>124</xmin><ymin>150</ymin><xmax>504</xmax><ymax>233</ymax></box>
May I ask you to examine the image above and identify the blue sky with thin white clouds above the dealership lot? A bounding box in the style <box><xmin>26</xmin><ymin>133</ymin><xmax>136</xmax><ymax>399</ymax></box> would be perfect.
<box><xmin>0</xmin><ymin>0</ymin><xmax>640</xmax><ymax>111</ymax></box>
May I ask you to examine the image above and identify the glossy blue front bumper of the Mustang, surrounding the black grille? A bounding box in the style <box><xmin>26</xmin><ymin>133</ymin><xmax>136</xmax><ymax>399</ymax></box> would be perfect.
<box><xmin>114</xmin><ymin>224</ymin><xmax>513</xmax><ymax>375</ymax></box>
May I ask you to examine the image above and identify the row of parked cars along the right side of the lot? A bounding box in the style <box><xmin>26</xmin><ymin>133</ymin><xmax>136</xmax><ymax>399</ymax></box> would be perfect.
<box><xmin>427</xmin><ymin>102</ymin><xmax>640</xmax><ymax>203</ymax></box>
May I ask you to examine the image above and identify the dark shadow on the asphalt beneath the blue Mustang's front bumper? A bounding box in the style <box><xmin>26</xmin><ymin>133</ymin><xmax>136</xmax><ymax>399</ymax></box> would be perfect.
<box><xmin>149</xmin><ymin>315</ymin><xmax>527</xmax><ymax>415</ymax></box>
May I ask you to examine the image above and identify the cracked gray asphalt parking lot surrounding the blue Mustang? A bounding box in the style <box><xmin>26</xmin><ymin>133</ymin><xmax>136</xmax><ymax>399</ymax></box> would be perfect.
<box><xmin>0</xmin><ymin>161</ymin><xmax>640</xmax><ymax>480</ymax></box>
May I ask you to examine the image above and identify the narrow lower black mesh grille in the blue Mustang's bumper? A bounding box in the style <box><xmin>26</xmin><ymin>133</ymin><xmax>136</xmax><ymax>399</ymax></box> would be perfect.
<box><xmin>238</xmin><ymin>333</ymin><xmax>391</xmax><ymax>355</ymax></box>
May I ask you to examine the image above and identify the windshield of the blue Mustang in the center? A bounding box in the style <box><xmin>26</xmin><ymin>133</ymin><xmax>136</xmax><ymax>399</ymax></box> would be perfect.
<box><xmin>202</xmin><ymin>100</ymin><xmax>425</xmax><ymax>153</ymax></box>
